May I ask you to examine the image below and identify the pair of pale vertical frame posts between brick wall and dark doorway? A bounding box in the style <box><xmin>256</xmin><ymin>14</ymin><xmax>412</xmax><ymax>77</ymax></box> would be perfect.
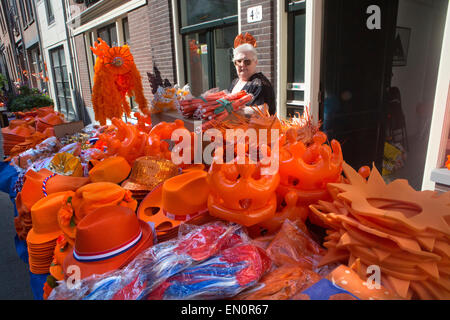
<box><xmin>276</xmin><ymin>0</ymin><xmax>323</xmax><ymax>124</ymax></box>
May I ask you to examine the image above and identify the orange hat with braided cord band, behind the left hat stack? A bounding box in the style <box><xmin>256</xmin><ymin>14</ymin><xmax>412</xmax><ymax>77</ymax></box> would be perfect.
<box><xmin>14</xmin><ymin>169</ymin><xmax>89</xmax><ymax>240</ymax></box>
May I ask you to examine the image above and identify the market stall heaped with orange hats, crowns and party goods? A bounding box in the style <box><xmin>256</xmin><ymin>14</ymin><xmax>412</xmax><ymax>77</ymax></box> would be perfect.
<box><xmin>1</xmin><ymin>37</ymin><xmax>450</xmax><ymax>300</ymax></box>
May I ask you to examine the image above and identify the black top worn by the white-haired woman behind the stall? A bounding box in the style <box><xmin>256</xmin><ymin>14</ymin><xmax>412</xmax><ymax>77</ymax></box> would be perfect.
<box><xmin>228</xmin><ymin>72</ymin><xmax>276</xmax><ymax>115</ymax></box>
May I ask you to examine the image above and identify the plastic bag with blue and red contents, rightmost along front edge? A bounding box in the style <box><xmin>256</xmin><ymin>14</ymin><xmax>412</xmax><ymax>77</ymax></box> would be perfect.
<box><xmin>148</xmin><ymin>244</ymin><xmax>271</xmax><ymax>300</ymax></box>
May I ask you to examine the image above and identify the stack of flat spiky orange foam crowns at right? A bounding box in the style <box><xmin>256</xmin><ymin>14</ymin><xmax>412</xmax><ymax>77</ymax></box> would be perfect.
<box><xmin>310</xmin><ymin>163</ymin><xmax>450</xmax><ymax>300</ymax></box>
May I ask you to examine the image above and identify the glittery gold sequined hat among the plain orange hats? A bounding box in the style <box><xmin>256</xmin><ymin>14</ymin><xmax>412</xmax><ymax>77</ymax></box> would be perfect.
<box><xmin>122</xmin><ymin>156</ymin><xmax>179</xmax><ymax>202</ymax></box>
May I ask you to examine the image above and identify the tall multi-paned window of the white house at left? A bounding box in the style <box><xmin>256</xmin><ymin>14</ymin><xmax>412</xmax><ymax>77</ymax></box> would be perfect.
<box><xmin>50</xmin><ymin>46</ymin><xmax>77</xmax><ymax>121</ymax></box>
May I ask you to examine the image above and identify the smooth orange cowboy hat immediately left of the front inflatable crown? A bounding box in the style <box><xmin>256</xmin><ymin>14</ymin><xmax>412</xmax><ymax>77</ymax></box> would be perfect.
<box><xmin>138</xmin><ymin>170</ymin><xmax>209</xmax><ymax>240</ymax></box>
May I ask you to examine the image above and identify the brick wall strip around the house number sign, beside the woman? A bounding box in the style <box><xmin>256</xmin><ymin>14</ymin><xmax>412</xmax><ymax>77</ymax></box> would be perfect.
<box><xmin>240</xmin><ymin>0</ymin><xmax>276</xmax><ymax>88</ymax></box>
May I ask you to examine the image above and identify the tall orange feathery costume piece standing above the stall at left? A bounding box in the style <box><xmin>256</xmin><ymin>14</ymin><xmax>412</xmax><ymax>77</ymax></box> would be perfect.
<box><xmin>91</xmin><ymin>38</ymin><xmax>150</xmax><ymax>125</ymax></box>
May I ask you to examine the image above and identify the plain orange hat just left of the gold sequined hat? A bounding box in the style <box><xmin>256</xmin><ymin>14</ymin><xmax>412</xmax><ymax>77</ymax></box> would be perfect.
<box><xmin>89</xmin><ymin>156</ymin><xmax>131</xmax><ymax>183</ymax></box>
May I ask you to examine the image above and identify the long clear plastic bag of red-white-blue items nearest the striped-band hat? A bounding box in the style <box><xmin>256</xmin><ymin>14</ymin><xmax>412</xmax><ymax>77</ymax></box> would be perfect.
<box><xmin>49</xmin><ymin>222</ymin><xmax>249</xmax><ymax>300</ymax></box>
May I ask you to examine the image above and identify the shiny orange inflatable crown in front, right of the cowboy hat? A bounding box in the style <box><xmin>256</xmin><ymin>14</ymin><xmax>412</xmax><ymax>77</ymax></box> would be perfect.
<box><xmin>208</xmin><ymin>149</ymin><xmax>280</xmax><ymax>226</ymax></box>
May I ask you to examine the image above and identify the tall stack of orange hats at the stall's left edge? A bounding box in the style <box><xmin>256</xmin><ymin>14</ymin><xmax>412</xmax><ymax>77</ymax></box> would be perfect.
<box><xmin>27</xmin><ymin>192</ymin><xmax>66</xmax><ymax>274</ymax></box>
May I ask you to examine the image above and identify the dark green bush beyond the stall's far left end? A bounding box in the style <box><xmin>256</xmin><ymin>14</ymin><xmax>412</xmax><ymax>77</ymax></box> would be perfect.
<box><xmin>8</xmin><ymin>86</ymin><xmax>54</xmax><ymax>112</ymax></box>
